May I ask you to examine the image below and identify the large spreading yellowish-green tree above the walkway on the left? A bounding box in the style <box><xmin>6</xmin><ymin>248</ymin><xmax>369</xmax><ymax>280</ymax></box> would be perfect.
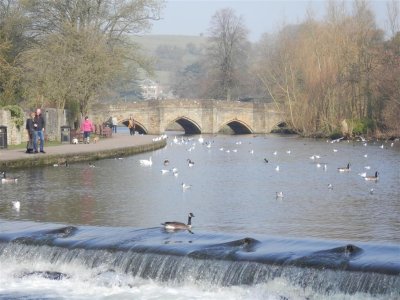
<box><xmin>22</xmin><ymin>0</ymin><xmax>162</xmax><ymax>115</ymax></box>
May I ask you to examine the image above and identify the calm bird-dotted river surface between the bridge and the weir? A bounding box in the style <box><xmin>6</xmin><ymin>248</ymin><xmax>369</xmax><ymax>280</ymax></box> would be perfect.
<box><xmin>0</xmin><ymin>135</ymin><xmax>400</xmax><ymax>243</ymax></box>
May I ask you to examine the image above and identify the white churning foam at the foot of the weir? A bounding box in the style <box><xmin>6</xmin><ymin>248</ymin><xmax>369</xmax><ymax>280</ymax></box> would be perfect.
<box><xmin>0</xmin><ymin>260</ymin><xmax>390</xmax><ymax>300</ymax></box>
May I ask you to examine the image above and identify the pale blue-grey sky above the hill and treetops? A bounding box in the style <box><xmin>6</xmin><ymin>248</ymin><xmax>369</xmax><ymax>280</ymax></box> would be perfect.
<box><xmin>150</xmin><ymin>0</ymin><xmax>388</xmax><ymax>42</ymax></box>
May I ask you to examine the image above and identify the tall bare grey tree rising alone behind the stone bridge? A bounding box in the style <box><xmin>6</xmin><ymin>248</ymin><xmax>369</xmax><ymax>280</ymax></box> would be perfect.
<box><xmin>207</xmin><ymin>8</ymin><xmax>249</xmax><ymax>100</ymax></box>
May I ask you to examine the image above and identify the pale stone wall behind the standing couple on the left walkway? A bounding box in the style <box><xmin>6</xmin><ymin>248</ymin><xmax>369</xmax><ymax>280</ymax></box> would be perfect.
<box><xmin>0</xmin><ymin>108</ymin><xmax>74</xmax><ymax>145</ymax></box>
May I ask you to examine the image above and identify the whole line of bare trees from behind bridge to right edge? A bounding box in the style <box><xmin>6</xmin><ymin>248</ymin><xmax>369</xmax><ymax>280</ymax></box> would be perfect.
<box><xmin>176</xmin><ymin>0</ymin><xmax>400</xmax><ymax>137</ymax></box>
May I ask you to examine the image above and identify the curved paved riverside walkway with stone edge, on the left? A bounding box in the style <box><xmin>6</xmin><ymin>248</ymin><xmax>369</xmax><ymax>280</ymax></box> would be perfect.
<box><xmin>0</xmin><ymin>133</ymin><xmax>166</xmax><ymax>170</ymax></box>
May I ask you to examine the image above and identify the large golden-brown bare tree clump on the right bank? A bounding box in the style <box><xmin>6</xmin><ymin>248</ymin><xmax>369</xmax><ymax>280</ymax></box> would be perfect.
<box><xmin>255</xmin><ymin>0</ymin><xmax>388</xmax><ymax>135</ymax></box>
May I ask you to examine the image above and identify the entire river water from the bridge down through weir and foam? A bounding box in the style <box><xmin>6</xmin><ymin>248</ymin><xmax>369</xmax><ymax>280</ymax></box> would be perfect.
<box><xmin>0</xmin><ymin>133</ymin><xmax>400</xmax><ymax>299</ymax></box>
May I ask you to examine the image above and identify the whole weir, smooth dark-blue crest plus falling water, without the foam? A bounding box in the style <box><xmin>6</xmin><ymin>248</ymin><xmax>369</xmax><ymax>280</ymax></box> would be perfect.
<box><xmin>0</xmin><ymin>222</ymin><xmax>400</xmax><ymax>298</ymax></box>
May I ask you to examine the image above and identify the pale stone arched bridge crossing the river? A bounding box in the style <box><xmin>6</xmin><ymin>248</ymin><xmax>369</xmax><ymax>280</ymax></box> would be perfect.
<box><xmin>91</xmin><ymin>99</ymin><xmax>285</xmax><ymax>134</ymax></box>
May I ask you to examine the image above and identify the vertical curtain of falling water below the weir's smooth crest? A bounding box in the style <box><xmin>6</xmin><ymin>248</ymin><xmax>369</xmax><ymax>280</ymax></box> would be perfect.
<box><xmin>0</xmin><ymin>240</ymin><xmax>400</xmax><ymax>297</ymax></box>
